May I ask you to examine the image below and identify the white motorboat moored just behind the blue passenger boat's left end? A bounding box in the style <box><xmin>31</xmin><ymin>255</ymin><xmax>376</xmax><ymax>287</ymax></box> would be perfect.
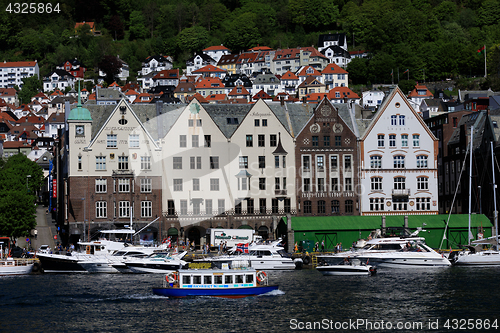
<box><xmin>123</xmin><ymin>251</ymin><xmax>187</xmax><ymax>274</ymax></box>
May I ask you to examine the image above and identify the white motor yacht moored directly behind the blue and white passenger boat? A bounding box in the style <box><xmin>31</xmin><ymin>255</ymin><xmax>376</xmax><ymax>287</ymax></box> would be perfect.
<box><xmin>195</xmin><ymin>239</ymin><xmax>301</xmax><ymax>270</ymax></box>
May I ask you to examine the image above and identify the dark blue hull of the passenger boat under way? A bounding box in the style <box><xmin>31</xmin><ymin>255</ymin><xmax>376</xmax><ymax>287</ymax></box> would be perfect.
<box><xmin>153</xmin><ymin>285</ymin><xmax>278</xmax><ymax>298</ymax></box>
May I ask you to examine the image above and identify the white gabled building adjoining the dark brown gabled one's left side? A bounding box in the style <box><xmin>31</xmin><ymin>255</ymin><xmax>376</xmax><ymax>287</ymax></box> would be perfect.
<box><xmin>231</xmin><ymin>99</ymin><xmax>296</xmax><ymax>219</ymax></box>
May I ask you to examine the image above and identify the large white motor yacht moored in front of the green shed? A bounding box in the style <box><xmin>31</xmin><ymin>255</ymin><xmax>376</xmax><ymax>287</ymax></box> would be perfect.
<box><xmin>356</xmin><ymin>237</ymin><xmax>451</xmax><ymax>268</ymax></box>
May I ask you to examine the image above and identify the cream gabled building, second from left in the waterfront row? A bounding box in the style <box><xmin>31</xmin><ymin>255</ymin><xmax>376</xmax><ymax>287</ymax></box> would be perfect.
<box><xmin>162</xmin><ymin>99</ymin><xmax>232</xmax><ymax>226</ymax></box>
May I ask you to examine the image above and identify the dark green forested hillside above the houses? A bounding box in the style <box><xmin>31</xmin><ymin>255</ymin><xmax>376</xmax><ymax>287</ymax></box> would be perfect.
<box><xmin>0</xmin><ymin>0</ymin><xmax>500</xmax><ymax>85</ymax></box>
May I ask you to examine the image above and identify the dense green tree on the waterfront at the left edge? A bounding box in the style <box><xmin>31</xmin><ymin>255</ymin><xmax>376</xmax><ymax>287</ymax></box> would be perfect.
<box><xmin>0</xmin><ymin>154</ymin><xmax>43</xmax><ymax>241</ymax></box>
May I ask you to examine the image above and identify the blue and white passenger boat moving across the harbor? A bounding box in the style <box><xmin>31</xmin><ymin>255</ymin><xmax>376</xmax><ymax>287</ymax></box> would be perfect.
<box><xmin>153</xmin><ymin>269</ymin><xmax>278</xmax><ymax>298</ymax></box>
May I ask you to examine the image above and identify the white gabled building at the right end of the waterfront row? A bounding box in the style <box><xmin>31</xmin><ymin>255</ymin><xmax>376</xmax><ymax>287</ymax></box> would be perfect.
<box><xmin>360</xmin><ymin>87</ymin><xmax>438</xmax><ymax>215</ymax></box>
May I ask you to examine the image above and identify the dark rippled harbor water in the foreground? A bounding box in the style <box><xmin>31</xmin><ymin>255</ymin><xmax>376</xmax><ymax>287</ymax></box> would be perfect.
<box><xmin>0</xmin><ymin>267</ymin><xmax>500</xmax><ymax>333</ymax></box>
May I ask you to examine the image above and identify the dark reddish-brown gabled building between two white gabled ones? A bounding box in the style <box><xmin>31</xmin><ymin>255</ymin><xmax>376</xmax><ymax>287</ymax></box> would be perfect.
<box><xmin>295</xmin><ymin>98</ymin><xmax>359</xmax><ymax>216</ymax></box>
